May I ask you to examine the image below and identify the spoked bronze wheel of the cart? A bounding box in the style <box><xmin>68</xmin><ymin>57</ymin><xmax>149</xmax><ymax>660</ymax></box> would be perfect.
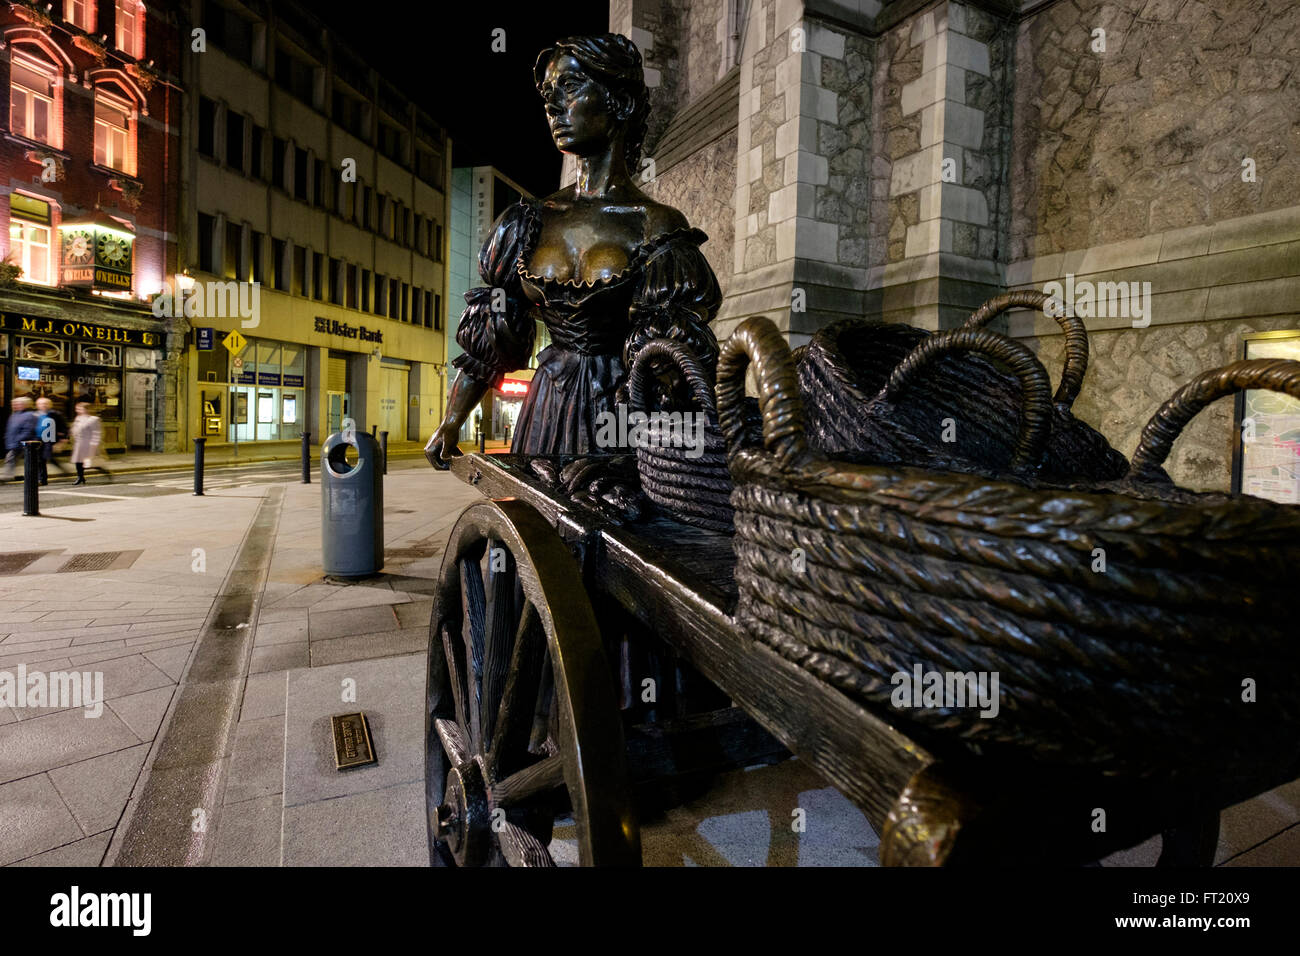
<box><xmin>425</xmin><ymin>498</ymin><xmax>641</xmax><ymax>866</ymax></box>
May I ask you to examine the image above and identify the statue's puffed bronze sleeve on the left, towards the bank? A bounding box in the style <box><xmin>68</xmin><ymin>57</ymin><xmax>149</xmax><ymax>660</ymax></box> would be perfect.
<box><xmin>451</xmin><ymin>202</ymin><xmax>537</xmax><ymax>388</ymax></box>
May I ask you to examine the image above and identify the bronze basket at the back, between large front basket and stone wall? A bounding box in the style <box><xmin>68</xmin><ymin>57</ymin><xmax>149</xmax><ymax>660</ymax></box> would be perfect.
<box><xmin>797</xmin><ymin>291</ymin><xmax>1128</xmax><ymax>481</ymax></box>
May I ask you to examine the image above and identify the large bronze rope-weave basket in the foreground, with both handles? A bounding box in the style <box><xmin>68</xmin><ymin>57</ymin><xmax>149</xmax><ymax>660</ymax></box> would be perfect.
<box><xmin>718</xmin><ymin>319</ymin><xmax>1300</xmax><ymax>780</ymax></box>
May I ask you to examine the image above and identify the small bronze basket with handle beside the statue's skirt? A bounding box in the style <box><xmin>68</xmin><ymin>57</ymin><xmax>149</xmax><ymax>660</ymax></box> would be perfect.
<box><xmin>628</xmin><ymin>338</ymin><xmax>732</xmax><ymax>533</ymax></box>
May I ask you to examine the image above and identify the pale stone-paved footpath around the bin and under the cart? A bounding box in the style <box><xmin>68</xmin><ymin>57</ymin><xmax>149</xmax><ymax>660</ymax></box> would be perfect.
<box><xmin>0</xmin><ymin>460</ymin><xmax>1300</xmax><ymax>866</ymax></box>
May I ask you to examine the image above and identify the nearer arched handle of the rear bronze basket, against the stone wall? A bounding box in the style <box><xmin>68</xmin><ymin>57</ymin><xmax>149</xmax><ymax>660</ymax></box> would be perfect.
<box><xmin>876</xmin><ymin>329</ymin><xmax>1052</xmax><ymax>471</ymax></box>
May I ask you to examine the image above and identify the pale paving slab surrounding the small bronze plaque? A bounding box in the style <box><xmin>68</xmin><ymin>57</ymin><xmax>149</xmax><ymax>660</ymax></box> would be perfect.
<box><xmin>285</xmin><ymin>654</ymin><xmax>425</xmax><ymax>806</ymax></box>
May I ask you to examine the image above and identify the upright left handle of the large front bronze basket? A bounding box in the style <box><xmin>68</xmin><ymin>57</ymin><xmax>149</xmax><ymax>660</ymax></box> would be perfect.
<box><xmin>718</xmin><ymin>315</ymin><xmax>809</xmax><ymax>467</ymax></box>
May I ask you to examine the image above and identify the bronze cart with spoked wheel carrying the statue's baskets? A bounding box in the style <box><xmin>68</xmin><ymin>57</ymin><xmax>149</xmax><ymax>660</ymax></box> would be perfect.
<box><xmin>426</xmin><ymin>454</ymin><xmax>1295</xmax><ymax>866</ymax></box>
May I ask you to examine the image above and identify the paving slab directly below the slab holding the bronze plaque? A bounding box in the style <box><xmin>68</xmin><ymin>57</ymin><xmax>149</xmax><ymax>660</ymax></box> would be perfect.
<box><xmin>282</xmin><ymin>782</ymin><xmax>429</xmax><ymax>866</ymax></box>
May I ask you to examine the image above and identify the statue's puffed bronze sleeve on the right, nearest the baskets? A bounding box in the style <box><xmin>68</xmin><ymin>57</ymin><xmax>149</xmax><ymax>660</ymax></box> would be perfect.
<box><xmin>623</xmin><ymin>229</ymin><xmax>723</xmax><ymax>373</ymax></box>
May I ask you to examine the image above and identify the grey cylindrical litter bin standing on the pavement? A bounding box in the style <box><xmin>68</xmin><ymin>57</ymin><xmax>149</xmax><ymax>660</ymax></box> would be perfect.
<box><xmin>321</xmin><ymin>432</ymin><xmax>384</xmax><ymax>578</ymax></box>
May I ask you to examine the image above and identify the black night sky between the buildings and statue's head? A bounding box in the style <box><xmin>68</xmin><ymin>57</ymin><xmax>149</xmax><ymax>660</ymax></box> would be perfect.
<box><xmin>311</xmin><ymin>0</ymin><xmax>610</xmax><ymax>195</ymax></box>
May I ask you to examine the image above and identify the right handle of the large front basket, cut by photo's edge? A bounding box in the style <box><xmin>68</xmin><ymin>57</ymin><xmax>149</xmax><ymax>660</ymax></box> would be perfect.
<box><xmin>1128</xmin><ymin>359</ymin><xmax>1300</xmax><ymax>481</ymax></box>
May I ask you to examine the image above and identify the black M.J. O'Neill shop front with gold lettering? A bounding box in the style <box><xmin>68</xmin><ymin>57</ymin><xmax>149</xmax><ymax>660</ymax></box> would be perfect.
<box><xmin>0</xmin><ymin>312</ymin><xmax>163</xmax><ymax>450</ymax></box>
